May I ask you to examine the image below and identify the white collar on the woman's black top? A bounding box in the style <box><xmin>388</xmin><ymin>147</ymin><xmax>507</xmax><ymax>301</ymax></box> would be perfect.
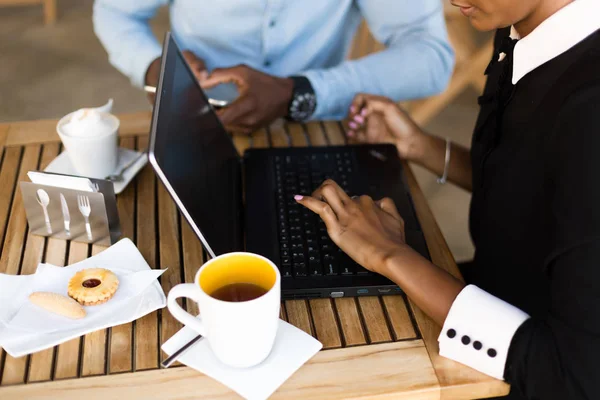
<box><xmin>510</xmin><ymin>0</ymin><xmax>600</xmax><ymax>85</ymax></box>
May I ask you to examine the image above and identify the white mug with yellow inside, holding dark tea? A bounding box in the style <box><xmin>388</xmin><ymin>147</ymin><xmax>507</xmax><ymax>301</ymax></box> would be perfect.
<box><xmin>167</xmin><ymin>252</ymin><xmax>281</xmax><ymax>368</ymax></box>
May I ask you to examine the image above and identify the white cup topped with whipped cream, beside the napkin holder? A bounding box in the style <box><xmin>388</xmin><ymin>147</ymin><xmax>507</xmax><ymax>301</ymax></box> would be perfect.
<box><xmin>56</xmin><ymin>109</ymin><xmax>120</xmax><ymax>179</ymax></box>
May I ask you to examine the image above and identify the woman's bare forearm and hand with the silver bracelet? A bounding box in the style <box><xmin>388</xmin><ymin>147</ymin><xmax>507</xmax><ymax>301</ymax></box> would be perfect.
<box><xmin>348</xmin><ymin>94</ymin><xmax>472</xmax><ymax>191</ymax></box>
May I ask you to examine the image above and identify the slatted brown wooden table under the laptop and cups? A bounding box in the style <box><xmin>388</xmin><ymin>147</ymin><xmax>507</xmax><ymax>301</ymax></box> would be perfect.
<box><xmin>0</xmin><ymin>113</ymin><xmax>508</xmax><ymax>400</ymax></box>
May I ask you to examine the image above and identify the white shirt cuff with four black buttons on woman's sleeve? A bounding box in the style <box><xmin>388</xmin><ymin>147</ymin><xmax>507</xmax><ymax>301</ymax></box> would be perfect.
<box><xmin>438</xmin><ymin>285</ymin><xmax>529</xmax><ymax>379</ymax></box>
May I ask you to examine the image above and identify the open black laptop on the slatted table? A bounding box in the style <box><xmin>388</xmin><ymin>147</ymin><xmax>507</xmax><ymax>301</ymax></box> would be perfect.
<box><xmin>149</xmin><ymin>34</ymin><xmax>429</xmax><ymax>299</ymax></box>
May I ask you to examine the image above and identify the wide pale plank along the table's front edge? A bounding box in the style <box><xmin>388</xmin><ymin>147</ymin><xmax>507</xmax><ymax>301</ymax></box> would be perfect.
<box><xmin>0</xmin><ymin>340</ymin><xmax>440</xmax><ymax>400</ymax></box>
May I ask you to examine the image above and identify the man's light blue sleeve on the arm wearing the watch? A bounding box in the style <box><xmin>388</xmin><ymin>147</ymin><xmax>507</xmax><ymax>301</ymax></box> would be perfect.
<box><xmin>302</xmin><ymin>0</ymin><xmax>454</xmax><ymax>119</ymax></box>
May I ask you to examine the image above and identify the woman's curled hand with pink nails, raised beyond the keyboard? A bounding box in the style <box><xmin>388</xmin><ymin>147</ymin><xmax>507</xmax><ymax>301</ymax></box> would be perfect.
<box><xmin>347</xmin><ymin>94</ymin><xmax>426</xmax><ymax>161</ymax></box>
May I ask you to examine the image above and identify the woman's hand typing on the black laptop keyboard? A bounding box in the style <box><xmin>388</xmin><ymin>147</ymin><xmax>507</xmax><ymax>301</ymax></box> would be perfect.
<box><xmin>295</xmin><ymin>179</ymin><xmax>407</xmax><ymax>275</ymax></box>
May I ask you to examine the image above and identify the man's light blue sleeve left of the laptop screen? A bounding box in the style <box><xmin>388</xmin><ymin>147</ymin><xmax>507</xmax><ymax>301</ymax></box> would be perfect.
<box><xmin>93</xmin><ymin>0</ymin><xmax>167</xmax><ymax>87</ymax></box>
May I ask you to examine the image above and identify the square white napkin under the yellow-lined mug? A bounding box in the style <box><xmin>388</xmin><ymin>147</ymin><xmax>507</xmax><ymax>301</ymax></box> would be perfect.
<box><xmin>162</xmin><ymin>320</ymin><xmax>323</xmax><ymax>400</ymax></box>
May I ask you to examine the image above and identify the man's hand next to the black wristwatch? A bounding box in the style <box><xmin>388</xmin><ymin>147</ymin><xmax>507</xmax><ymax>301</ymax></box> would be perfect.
<box><xmin>202</xmin><ymin>65</ymin><xmax>294</xmax><ymax>134</ymax></box>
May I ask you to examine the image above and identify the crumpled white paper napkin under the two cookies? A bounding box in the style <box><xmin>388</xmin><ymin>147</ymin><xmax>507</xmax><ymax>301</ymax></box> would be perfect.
<box><xmin>0</xmin><ymin>239</ymin><xmax>166</xmax><ymax>357</ymax></box>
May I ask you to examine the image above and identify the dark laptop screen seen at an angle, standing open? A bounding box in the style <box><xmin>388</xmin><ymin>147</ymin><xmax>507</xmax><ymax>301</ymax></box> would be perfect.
<box><xmin>150</xmin><ymin>34</ymin><xmax>242</xmax><ymax>256</ymax></box>
